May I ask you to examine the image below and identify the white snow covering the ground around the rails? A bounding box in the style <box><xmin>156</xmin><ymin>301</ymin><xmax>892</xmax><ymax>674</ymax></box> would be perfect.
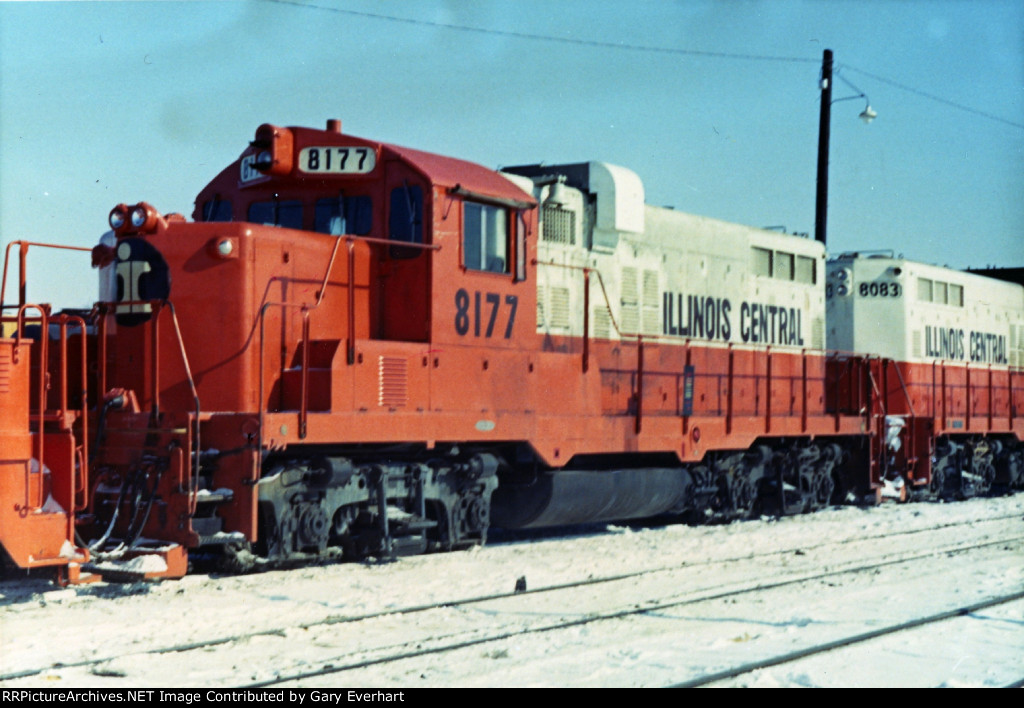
<box><xmin>0</xmin><ymin>495</ymin><xmax>1024</xmax><ymax>688</ymax></box>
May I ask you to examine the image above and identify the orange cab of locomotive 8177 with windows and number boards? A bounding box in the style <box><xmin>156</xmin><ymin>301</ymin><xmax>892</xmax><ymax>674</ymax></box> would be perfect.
<box><xmin>194</xmin><ymin>121</ymin><xmax>534</xmax><ymax>352</ymax></box>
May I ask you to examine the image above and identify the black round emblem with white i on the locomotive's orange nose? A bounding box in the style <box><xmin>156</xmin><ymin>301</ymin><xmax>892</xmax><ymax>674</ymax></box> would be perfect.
<box><xmin>115</xmin><ymin>239</ymin><xmax>171</xmax><ymax>327</ymax></box>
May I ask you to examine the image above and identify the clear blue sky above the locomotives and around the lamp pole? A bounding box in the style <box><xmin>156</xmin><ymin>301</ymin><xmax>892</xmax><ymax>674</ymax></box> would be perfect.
<box><xmin>0</xmin><ymin>0</ymin><xmax>1024</xmax><ymax>305</ymax></box>
